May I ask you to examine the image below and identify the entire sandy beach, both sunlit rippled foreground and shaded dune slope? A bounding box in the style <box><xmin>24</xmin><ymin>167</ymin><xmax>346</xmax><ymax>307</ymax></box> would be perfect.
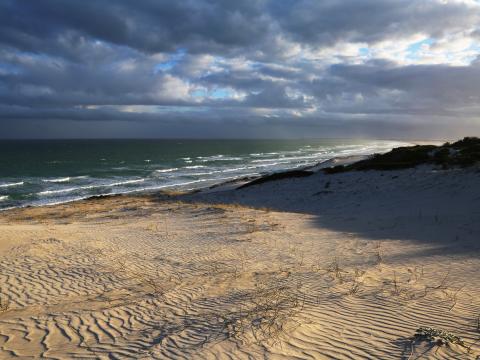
<box><xmin>0</xmin><ymin>162</ymin><xmax>480</xmax><ymax>359</ymax></box>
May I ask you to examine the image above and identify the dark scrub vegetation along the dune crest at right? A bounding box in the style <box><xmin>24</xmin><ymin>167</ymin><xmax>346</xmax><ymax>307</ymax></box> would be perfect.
<box><xmin>324</xmin><ymin>137</ymin><xmax>480</xmax><ymax>174</ymax></box>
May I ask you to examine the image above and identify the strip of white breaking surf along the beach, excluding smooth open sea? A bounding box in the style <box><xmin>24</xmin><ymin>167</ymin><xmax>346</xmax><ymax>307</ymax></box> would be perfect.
<box><xmin>0</xmin><ymin>140</ymin><xmax>416</xmax><ymax>210</ymax></box>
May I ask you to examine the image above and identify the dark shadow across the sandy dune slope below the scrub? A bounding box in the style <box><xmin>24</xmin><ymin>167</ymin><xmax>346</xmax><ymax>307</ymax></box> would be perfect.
<box><xmin>174</xmin><ymin>167</ymin><xmax>480</xmax><ymax>257</ymax></box>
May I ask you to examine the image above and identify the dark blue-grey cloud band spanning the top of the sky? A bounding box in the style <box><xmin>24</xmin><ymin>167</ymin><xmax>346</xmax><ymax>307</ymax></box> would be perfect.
<box><xmin>0</xmin><ymin>0</ymin><xmax>479</xmax><ymax>53</ymax></box>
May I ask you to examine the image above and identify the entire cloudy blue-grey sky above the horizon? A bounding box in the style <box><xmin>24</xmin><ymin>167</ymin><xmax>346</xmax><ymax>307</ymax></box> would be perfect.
<box><xmin>0</xmin><ymin>0</ymin><xmax>480</xmax><ymax>139</ymax></box>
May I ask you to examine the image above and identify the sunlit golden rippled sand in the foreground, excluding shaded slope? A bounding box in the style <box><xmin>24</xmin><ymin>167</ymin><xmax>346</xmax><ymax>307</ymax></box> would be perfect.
<box><xmin>0</xmin><ymin>199</ymin><xmax>480</xmax><ymax>359</ymax></box>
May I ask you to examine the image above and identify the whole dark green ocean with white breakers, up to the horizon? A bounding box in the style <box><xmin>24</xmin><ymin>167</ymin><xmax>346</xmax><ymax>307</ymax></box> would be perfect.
<box><xmin>0</xmin><ymin>139</ymin><xmax>406</xmax><ymax>210</ymax></box>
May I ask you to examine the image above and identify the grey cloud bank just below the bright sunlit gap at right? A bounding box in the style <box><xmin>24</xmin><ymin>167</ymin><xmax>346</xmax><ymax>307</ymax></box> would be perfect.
<box><xmin>320</xmin><ymin>64</ymin><xmax>480</xmax><ymax>116</ymax></box>
